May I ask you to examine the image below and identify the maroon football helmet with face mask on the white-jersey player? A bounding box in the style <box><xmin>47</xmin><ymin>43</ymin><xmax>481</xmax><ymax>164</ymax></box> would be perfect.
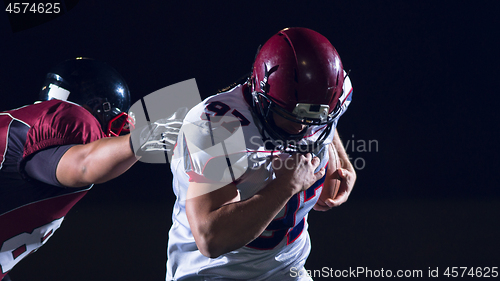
<box><xmin>251</xmin><ymin>27</ymin><xmax>344</xmax><ymax>148</ymax></box>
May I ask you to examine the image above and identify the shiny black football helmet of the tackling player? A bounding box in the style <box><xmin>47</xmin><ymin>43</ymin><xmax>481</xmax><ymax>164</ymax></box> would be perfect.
<box><xmin>39</xmin><ymin>57</ymin><xmax>134</xmax><ymax>136</ymax></box>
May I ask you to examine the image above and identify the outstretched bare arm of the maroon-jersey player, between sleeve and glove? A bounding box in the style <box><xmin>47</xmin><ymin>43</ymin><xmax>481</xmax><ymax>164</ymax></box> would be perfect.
<box><xmin>56</xmin><ymin>135</ymin><xmax>137</xmax><ymax>187</ymax></box>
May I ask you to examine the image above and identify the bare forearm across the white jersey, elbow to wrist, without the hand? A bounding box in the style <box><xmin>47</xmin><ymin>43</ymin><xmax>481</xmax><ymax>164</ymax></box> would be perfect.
<box><xmin>190</xmin><ymin>180</ymin><xmax>293</xmax><ymax>258</ymax></box>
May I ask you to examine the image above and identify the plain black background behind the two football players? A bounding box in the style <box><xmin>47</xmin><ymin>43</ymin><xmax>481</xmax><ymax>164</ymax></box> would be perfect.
<box><xmin>0</xmin><ymin>0</ymin><xmax>500</xmax><ymax>281</ymax></box>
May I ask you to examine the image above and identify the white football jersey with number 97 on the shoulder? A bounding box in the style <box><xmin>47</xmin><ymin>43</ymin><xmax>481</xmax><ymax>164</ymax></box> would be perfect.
<box><xmin>166</xmin><ymin>77</ymin><xmax>352</xmax><ymax>280</ymax></box>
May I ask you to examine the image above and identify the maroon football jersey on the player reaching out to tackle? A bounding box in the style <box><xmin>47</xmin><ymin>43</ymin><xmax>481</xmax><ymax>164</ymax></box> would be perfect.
<box><xmin>0</xmin><ymin>100</ymin><xmax>104</xmax><ymax>280</ymax></box>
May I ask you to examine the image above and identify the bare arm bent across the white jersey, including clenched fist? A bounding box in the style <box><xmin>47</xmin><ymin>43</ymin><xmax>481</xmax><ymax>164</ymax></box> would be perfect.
<box><xmin>186</xmin><ymin>154</ymin><xmax>325</xmax><ymax>258</ymax></box>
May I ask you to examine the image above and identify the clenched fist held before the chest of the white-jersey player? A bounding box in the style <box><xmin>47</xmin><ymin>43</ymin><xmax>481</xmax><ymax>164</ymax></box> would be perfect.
<box><xmin>272</xmin><ymin>153</ymin><xmax>325</xmax><ymax>194</ymax></box>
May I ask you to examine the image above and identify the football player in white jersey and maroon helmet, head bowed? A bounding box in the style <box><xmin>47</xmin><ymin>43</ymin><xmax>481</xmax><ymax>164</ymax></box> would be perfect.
<box><xmin>166</xmin><ymin>28</ymin><xmax>356</xmax><ymax>280</ymax></box>
